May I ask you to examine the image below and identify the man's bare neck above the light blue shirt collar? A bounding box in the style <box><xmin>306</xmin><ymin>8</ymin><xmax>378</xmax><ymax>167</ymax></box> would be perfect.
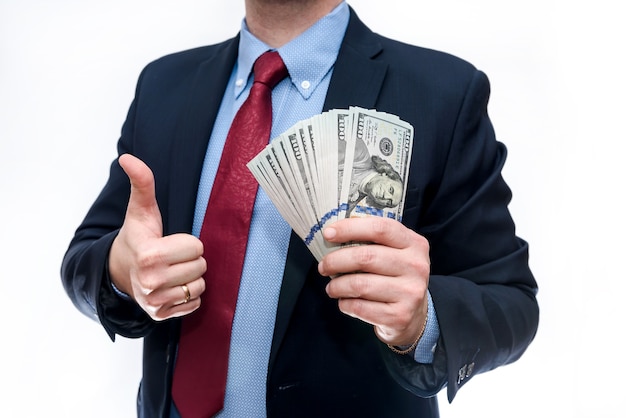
<box><xmin>246</xmin><ymin>0</ymin><xmax>342</xmax><ymax>48</ymax></box>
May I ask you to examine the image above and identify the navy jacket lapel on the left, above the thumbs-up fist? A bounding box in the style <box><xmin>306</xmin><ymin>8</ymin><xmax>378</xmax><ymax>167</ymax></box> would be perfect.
<box><xmin>164</xmin><ymin>37</ymin><xmax>239</xmax><ymax>233</ymax></box>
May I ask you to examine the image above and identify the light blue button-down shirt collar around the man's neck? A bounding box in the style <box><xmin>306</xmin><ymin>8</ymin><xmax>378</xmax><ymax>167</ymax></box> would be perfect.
<box><xmin>234</xmin><ymin>1</ymin><xmax>350</xmax><ymax>99</ymax></box>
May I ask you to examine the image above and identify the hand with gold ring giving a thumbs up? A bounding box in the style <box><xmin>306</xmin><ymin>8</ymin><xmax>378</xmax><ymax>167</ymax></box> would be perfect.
<box><xmin>109</xmin><ymin>154</ymin><xmax>206</xmax><ymax>321</ymax></box>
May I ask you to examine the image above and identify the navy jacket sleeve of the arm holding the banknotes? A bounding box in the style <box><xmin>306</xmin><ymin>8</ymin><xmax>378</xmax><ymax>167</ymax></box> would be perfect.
<box><xmin>384</xmin><ymin>70</ymin><xmax>539</xmax><ymax>401</ymax></box>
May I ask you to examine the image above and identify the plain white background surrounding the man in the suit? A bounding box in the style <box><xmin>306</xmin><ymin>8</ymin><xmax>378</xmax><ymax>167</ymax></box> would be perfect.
<box><xmin>0</xmin><ymin>0</ymin><xmax>626</xmax><ymax>418</ymax></box>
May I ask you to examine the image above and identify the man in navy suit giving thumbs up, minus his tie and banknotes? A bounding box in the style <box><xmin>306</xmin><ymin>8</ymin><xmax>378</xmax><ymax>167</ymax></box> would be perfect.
<box><xmin>62</xmin><ymin>0</ymin><xmax>538</xmax><ymax>417</ymax></box>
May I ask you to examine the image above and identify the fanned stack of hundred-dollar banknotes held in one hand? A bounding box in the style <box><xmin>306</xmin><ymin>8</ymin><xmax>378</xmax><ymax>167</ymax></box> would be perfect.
<box><xmin>248</xmin><ymin>107</ymin><xmax>413</xmax><ymax>261</ymax></box>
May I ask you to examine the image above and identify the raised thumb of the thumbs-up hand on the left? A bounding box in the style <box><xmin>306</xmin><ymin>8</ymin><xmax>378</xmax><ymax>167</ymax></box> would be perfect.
<box><xmin>118</xmin><ymin>154</ymin><xmax>162</xmax><ymax>234</ymax></box>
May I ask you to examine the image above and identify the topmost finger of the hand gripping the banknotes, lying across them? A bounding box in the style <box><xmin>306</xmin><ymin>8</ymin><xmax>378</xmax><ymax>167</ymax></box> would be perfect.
<box><xmin>323</xmin><ymin>216</ymin><xmax>411</xmax><ymax>248</ymax></box>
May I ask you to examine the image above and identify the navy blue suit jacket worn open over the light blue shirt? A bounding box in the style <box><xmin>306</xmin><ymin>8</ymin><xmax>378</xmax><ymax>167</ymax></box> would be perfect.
<box><xmin>62</xmin><ymin>7</ymin><xmax>538</xmax><ymax>417</ymax></box>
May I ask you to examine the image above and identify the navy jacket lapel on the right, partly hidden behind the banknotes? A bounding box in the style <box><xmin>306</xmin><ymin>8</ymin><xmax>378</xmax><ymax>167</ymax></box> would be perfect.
<box><xmin>269</xmin><ymin>9</ymin><xmax>387</xmax><ymax>371</ymax></box>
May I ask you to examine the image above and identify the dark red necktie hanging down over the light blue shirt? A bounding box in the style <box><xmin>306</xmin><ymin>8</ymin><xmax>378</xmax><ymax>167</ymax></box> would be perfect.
<box><xmin>172</xmin><ymin>52</ymin><xmax>288</xmax><ymax>418</ymax></box>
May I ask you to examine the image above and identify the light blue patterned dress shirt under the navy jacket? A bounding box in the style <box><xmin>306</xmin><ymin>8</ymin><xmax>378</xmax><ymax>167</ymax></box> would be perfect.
<box><xmin>171</xmin><ymin>2</ymin><xmax>439</xmax><ymax>418</ymax></box>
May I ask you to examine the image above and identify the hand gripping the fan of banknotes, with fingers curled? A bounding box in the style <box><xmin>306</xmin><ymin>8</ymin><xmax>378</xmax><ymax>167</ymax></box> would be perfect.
<box><xmin>318</xmin><ymin>217</ymin><xmax>430</xmax><ymax>346</ymax></box>
